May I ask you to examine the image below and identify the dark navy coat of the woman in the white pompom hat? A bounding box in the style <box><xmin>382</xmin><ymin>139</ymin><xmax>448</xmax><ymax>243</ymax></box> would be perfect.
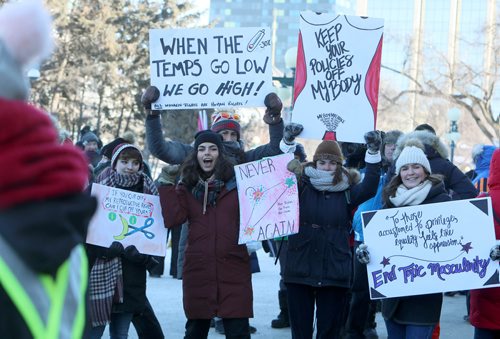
<box><xmin>382</xmin><ymin>183</ymin><xmax>451</xmax><ymax>326</ymax></box>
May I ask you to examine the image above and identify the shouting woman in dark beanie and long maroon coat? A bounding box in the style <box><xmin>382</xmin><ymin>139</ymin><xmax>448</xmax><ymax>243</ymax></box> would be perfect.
<box><xmin>162</xmin><ymin>130</ymin><xmax>253</xmax><ymax>339</ymax></box>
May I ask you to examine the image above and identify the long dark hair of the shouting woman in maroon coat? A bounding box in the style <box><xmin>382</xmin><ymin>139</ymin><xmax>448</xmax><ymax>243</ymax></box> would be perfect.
<box><xmin>181</xmin><ymin>149</ymin><xmax>234</xmax><ymax>187</ymax></box>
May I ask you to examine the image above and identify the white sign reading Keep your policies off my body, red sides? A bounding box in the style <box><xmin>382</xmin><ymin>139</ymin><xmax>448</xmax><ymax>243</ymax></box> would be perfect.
<box><xmin>292</xmin><ymin>11</ymin><xmax>384</xmax><ymax>143</ymax></box>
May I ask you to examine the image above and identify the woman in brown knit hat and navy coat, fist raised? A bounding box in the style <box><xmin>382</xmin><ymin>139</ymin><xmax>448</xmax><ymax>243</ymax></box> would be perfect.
<box><xmin>284</xmin><ymin>131</ymin><xmax>381</xmax><ymax>339</ymax></box>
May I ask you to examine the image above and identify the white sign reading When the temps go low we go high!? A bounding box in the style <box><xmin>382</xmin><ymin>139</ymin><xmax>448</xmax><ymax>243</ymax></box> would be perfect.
<box><xmin>149</xmin><ymin>27</ymin><xmax>272</xmax><ymax>110</ymax></box>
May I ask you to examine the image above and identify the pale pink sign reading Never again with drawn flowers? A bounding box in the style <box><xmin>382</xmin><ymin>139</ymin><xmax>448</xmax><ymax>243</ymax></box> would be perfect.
<box><xmin>234</xmin><ymin>154</ymin><xmax>299</xmax><ymax>244</ymax></box>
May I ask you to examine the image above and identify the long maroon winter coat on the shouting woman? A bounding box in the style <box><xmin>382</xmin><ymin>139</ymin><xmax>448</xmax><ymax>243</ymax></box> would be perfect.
<box><xmin>159</xmin><ymin>178</ymin><xmax>253</xmax><ymax>319</ymax></box>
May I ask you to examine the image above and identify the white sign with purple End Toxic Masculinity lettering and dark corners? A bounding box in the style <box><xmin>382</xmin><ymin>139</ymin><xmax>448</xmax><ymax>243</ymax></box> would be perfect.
<box><xmin>362</xmin><ymin>198</ymin><xmax>500</xmax><ymax>299</ymax></box>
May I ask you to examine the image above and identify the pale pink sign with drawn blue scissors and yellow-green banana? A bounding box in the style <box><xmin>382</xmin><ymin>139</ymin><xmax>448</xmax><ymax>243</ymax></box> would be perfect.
<box><xmin>87</xmin><ymin>184</ymin><xmax>167</xmax><ymax>257</ymax></box>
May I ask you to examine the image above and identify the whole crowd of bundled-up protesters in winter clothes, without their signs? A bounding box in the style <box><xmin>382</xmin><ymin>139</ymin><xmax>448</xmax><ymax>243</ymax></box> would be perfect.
<box><xmin>0</xmin><ymin>0</ymin><xmax>500</xmax><ymax>339</ymax></box>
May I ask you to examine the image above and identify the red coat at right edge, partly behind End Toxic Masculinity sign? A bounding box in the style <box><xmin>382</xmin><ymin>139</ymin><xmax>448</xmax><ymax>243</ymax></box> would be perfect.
<box><xmin>470</xmin><ymin>149</ymin><xmax>500</xmax><ymax>330</ymax></box>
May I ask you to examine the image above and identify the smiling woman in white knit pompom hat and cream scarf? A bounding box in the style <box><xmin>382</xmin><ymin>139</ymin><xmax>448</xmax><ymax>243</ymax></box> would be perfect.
<box><xmin>356</xmin><ymin>139</ymin><xmax>451</xmax><ymax>339</ymax></box>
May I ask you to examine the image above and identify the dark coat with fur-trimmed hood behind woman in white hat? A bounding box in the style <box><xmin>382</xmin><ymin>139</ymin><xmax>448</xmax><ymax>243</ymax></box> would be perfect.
<box><xmin>386</xmin><ymin>131</ymin><xmax>477</xmax><ymax>200</ymax></box>
